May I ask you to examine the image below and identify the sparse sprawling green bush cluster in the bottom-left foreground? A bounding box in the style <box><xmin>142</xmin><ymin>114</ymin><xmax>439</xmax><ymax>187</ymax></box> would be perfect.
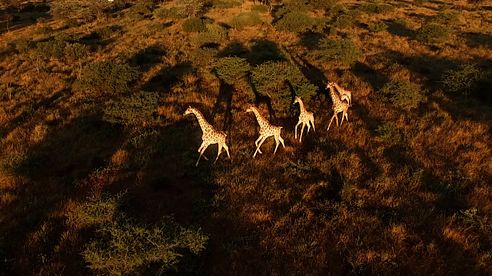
<box><xmin>68</xmin><ymin>197</ymin><xmax>208</xmax><ymax>275</ymax></box>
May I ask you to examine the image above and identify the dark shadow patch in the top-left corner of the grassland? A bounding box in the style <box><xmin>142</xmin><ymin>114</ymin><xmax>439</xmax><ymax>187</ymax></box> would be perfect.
<box><xmin>0</xmin><ymin>2</ymin><xmax>51</xmax><ymax>34</ymax></box>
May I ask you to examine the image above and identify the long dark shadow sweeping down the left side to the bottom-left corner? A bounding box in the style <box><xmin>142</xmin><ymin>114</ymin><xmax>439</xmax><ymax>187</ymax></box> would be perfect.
<box><xmin>0</xmin><ymin>115</ymin><xmax>122</xmax><ymax>275</ymax></box>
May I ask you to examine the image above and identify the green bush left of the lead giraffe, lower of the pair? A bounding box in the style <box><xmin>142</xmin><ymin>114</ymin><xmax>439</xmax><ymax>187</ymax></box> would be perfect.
<box><xmin>103</xmin><ymin>92</ymin><xmax>159</xmax><ymax>125</ymax></box>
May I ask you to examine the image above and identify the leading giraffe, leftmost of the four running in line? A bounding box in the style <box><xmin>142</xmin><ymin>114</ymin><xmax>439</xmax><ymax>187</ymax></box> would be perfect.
<box><xmin>183</xmin><ymin>106</ymin><xmax>231</xmax><ymax>167</ymax></box>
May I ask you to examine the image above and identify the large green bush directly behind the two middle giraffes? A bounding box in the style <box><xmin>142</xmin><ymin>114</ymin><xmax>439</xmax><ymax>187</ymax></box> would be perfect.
<box><xmin>252</xmin><ymin>61</ymin><xmax>317</xmax><ymax>112</ymax></box>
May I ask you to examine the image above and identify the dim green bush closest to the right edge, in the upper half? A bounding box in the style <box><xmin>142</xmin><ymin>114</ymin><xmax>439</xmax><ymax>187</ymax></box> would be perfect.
<box><xmin>442</xmin><ymin>64</ymin><xmax>483</xmax><ymax>95</ymax></box>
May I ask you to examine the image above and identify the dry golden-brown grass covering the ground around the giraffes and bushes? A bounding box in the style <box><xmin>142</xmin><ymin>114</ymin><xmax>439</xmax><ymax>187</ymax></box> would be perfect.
<box><xmin>0</xmin><ymin>0</ymin><xmax>492</xmax><ymax>275</ymax></box>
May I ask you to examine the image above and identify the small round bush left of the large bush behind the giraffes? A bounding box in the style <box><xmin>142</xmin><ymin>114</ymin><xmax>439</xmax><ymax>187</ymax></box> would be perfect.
<box><xmin>214</xmin><ymin>57</ymin><xmax>250</xmax><ymax>85</ymax></box>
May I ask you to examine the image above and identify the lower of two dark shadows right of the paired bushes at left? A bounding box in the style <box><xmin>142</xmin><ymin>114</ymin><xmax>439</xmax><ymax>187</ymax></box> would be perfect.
<box><xmin>142</xmin><ymin>62</ymin><xmax>194</xmax><ymax>93</ymax></box>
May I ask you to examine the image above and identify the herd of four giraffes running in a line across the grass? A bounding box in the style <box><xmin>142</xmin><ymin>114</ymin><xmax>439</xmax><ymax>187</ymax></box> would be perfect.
<box><xmin>183</xmin><ymin>82</ymin><xmax>352</xmax><ymax>166</ymax></box>
